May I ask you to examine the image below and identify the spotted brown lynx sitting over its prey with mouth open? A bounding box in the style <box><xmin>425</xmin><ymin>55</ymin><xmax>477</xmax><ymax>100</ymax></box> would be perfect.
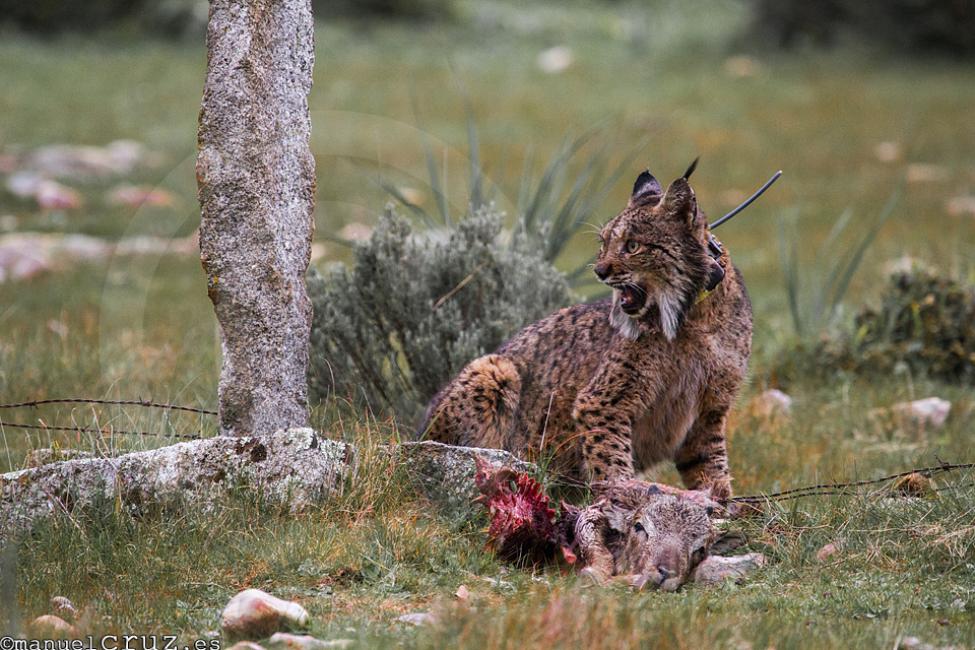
<box><xmin>421</xmin><ymin>161</ymin><xmax>752</xmax><ymax>501</ymax></box>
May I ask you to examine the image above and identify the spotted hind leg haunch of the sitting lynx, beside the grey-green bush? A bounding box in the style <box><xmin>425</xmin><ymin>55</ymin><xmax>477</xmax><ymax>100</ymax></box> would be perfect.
<box><xmin>426</xmin><ymin>354</ymin><xmax>521</xmax><ymax>449</ymax></box>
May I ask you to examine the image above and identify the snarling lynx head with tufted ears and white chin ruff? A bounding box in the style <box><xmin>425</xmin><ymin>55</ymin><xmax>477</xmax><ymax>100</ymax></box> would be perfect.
<box><xmin>594</xmin><ymin>160</ymin><xmax>720</xmax><ymax>340</ymax></box>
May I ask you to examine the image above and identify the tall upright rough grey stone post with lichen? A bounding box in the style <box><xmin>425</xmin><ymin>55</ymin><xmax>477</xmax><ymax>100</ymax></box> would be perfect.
<box><xmin>196</xmin><ymin>0</ymin><xmax>315</xmax><ymax>435</ymax></box>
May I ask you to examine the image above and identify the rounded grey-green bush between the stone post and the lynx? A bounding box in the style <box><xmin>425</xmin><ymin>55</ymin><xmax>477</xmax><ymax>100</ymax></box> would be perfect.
<box><xmin>308</xmin><ymin>207</ymin><xmax>571</xmax><ymax>421</ymax></box>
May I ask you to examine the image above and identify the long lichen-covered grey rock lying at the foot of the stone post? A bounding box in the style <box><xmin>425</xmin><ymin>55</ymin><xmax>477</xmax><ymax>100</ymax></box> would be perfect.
<box><xmin>0</xmin><ymin>429</ymin><xmax>350</xmax><ymax>538</ymax></box>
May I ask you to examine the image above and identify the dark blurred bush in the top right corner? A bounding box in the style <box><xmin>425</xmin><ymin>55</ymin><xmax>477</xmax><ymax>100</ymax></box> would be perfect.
<box><xmin>753</xmin><ymin>0</ymin><xmax>975</xmax><ymax>56</ymax></box>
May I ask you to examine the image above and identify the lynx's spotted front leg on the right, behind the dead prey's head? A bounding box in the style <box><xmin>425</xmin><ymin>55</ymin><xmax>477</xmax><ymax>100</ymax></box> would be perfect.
<box><xmin>674</xmin><ymin>407</ymin><xmax>731</xmax><ymax>503</ymax></box>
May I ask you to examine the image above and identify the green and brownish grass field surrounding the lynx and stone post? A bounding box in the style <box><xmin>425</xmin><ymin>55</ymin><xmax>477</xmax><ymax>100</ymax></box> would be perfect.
<box><xmin>0</xmin><ymin>2</ymin><xmax>975</xmax><ymax>648</ymax></box>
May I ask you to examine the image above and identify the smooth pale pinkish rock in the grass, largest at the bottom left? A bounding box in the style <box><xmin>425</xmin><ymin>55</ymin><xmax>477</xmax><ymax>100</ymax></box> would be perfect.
<box><xmin>220</xmin><ymin>589</ymin><xmax>308</xmax><ymax>636</ymax></box>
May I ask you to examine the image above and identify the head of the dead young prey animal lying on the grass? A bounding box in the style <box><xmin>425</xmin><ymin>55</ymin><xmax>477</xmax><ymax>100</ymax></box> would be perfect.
<box><xmin>616</xmin><ymin>495</ymin><xmax>717</xmax><ymax>591</ymax></box>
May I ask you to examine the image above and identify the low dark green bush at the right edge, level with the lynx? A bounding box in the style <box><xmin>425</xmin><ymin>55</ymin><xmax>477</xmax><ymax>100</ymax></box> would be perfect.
<box><xmin>779</xmin><ymin>269</ymin><xmax>975</xmax><ymax>385</ymax></box>
